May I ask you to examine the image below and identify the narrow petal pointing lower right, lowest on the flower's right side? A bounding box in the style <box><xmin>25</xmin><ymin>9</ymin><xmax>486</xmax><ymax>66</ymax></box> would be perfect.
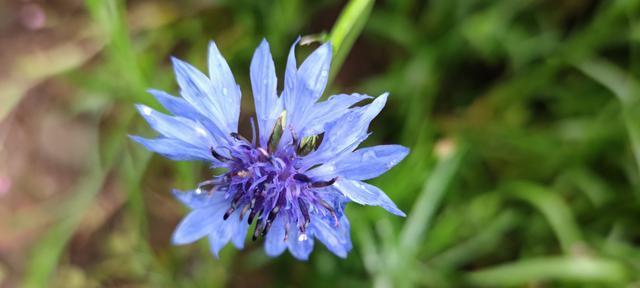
<box><xmin>332</xmin><ymin>178</ymin><xmax>406</xmax><ymax>217</ymax></box>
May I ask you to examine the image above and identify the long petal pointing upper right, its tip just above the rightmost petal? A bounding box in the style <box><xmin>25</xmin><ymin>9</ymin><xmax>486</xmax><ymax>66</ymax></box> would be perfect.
<box><xmin>300</xmin><ymin>93</ymin><xmax>388</xmax><ymax>168</ymax></box>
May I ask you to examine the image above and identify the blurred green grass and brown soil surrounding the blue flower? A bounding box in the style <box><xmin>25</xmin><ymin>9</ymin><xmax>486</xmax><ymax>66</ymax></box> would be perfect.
<box><xmin>0</xmin><ymin>0</ymin><xmax>640</xmax><ymax>287</ymax></box>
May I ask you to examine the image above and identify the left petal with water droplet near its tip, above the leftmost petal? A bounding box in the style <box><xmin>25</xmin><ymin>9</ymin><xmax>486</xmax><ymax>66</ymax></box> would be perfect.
<box><xmin>136</xmin><ymin>104</ymin><xmax>215</xmax><ymax>147</ymax></box>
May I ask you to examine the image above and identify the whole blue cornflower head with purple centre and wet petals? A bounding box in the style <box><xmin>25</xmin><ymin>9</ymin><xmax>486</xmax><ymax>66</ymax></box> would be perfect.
<box><xmin>131</xmin><ymin>40</ymin><xmax>408</xmax><ymax>260</ymax></box>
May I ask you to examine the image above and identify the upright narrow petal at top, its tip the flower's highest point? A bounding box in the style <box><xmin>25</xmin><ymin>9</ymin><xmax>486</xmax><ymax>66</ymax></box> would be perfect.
<box><xmin>250</xmin><ymin>40</ymin><xmax>282</xmax><ymax>147</ymax></box>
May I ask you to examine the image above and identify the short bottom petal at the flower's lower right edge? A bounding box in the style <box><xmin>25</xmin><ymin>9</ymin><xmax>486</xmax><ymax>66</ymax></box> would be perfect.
<box><xmin>311</xmin><ymin>214</ymin><xmax>352</xmax><ymax>258</ymax></box>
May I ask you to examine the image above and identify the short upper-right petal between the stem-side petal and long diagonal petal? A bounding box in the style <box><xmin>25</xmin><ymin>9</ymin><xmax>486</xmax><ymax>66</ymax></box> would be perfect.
<box><xmin>298</xmin><ymin>94</ymin><xmax>372</xmax><ymax>139</ymax></box>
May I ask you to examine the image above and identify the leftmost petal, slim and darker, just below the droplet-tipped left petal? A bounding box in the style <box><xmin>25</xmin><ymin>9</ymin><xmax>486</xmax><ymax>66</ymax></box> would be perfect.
<box><xmin>129</xmin><ymin>135</ymin><xmax>219</xmax><ymax>165</ymax></box>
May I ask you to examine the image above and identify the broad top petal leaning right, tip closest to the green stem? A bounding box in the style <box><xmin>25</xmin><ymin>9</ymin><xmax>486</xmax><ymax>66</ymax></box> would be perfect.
<box><xmin>284</xmin><ymin>42</ymin><xmax>332</xmax><ymax>135</ymax></box>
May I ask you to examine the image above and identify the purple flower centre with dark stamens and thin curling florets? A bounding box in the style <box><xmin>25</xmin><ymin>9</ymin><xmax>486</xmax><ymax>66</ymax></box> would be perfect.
<box><xmin>196</xmin><ymin>133</ymin><xmax>338</xmax><ymax>241</ymax></box>
